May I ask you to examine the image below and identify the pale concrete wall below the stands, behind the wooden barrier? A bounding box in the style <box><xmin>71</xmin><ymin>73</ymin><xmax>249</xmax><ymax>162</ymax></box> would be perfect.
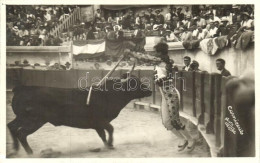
<box><xmin>6</xmin><ymin>45</ymin><xmax>255</xmax><ymax>76</ymax></box>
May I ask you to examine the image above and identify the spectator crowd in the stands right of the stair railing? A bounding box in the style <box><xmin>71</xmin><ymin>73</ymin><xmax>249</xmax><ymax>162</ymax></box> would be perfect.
<box><xmin>64</xmin><ymin>5</ymin><xmax>254</xmax><ymax>42</ymax></box>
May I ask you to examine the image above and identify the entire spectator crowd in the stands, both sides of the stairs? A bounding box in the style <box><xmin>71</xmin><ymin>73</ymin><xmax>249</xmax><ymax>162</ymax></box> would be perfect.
<box><xmin>7</xmin><ymin>5</ymin><xmax>254</xmax><ymax>46</ymax></box>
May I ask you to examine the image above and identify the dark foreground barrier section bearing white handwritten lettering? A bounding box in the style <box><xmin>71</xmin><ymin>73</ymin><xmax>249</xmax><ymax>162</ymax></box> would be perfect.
<box><xmin>223</xmin><ymin>78</ymin><xmax>255</xmax><ymax>157</ymax></box>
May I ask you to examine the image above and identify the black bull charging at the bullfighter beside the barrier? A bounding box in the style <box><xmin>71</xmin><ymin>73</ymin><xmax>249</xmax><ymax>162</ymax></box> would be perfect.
<box><xmin>7</xmin><ymin>76</ymin><xmax>151</xmax><ymax>154</ymax></box>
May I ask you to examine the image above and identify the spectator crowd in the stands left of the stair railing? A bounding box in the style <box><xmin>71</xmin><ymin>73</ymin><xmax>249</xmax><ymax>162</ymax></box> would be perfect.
<box><xmin>6</xmin><ymin>5</ymin><xmax>76</xmax><ymax>46</ymax></box>
